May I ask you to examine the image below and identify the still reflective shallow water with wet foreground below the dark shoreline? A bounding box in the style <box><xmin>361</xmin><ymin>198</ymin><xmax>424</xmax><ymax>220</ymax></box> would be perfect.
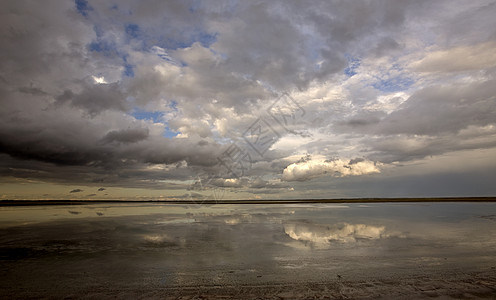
<box><xmin>0</xmin><ymin>203</ymin><xmax>496</xmax><ymax>298</ymax></box>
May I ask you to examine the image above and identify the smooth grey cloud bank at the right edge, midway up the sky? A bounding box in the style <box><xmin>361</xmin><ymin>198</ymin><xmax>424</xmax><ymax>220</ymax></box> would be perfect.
<box><xmin>378</xmin><ymin>80</ymin><xmax>496</xmax><ymax>135</ymax></box>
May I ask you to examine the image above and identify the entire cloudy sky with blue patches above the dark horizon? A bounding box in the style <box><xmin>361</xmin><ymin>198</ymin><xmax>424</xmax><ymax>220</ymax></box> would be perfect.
<box><xmin>0</xmin><ymin>0</ymin><xmax>496</xmax><ymax>201</ymax></box>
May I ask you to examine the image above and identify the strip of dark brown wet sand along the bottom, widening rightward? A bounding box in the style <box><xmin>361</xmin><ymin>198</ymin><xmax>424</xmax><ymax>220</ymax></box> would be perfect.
<box><xmin>2</xmin><ymin>271</ymin><xmax>496</xmax><ymax>299</ymax></box>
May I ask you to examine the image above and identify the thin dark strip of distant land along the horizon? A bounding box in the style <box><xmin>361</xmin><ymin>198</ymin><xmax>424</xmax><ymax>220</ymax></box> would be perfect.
<box><xmin>0</xmin><ymin>197</ymin><xmax>496</xmax><ymax>207</ymax></box>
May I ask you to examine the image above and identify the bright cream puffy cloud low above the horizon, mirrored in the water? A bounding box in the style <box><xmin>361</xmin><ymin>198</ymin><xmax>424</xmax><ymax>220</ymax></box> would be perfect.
<box><xmin>282</xmin><ymin>159</ymin><xmax>380</xmax><ymax>181</ymax></box>
